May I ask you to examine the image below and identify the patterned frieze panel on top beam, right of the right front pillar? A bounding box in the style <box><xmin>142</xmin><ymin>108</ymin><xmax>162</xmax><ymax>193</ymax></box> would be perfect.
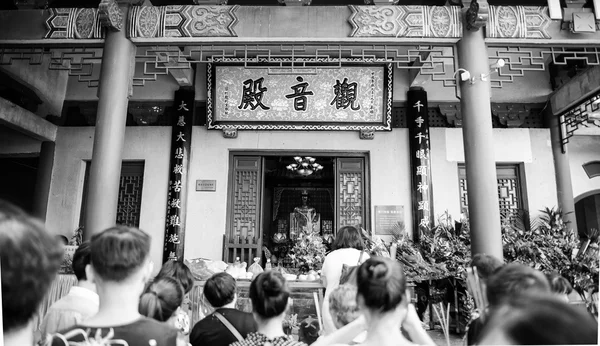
<box><xmin>486</xmin><ymin>6</ymin><xmax>552</xmax><ymax>39</ymax></box>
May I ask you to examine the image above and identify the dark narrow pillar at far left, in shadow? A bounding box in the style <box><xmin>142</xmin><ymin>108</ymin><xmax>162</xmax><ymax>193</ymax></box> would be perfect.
<box><xmin>33</xmin><ymin>141</ymin><xmax>56</xmax><ymax>220</ymax></box>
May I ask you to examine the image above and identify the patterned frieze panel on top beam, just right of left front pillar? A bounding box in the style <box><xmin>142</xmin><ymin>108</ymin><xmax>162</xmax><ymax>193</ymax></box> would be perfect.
<box><xmin>129</xmin><ymin>5</ymin><xmax>237</xmax><ymax>38</ymax></box>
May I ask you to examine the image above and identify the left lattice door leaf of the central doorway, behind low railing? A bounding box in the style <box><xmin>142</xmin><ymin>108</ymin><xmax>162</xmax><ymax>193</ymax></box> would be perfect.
<box><xmin>223</xmin><ymin>156</ymin><xmax>262</xmax><ymax>260</ymax></box>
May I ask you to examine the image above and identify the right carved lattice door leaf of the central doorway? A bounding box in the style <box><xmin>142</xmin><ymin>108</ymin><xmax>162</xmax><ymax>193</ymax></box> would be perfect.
<box><xmin>335</xmin><ymin>158</ymin><xmax>366</xmax><ymax>231</ymax></box>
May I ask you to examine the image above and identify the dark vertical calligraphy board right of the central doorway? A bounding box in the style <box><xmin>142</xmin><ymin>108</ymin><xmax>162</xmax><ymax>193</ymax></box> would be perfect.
<box><xmin>406</xmin><ymin>87</ymin><xmax>434</xmax><ymax>241</ymax></box>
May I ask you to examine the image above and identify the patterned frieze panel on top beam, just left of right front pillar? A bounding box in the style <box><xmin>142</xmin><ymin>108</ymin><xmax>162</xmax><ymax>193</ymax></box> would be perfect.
<box><xmin>349</xmin><ymin>6</ymin><xmax>462</xmax><ymax>38</ymax></box>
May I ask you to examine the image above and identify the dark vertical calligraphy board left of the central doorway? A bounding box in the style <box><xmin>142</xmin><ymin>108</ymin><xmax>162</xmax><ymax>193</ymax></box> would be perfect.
<box><xmin>163</xmin><ymin>88</ymin><xmax>195</xmax><ymax>262</ymax></box>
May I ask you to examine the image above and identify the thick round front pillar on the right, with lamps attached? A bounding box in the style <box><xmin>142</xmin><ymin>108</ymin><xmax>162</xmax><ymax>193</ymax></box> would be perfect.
<box><xmin>458</xmin><ymin>24</ymin><xmax>503</xmax><ymax>259</ymax></box>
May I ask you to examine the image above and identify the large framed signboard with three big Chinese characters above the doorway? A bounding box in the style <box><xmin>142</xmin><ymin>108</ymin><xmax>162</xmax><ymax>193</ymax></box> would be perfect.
<box><xmin>207</xmin><ymin>64</ymin><xmax>392</xmax><ymax>131</ymax></box>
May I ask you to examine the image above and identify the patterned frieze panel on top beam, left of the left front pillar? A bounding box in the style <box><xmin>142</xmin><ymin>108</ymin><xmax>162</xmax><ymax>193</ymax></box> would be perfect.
<box><xmin>45</xmin><ymin>8</ymin><xmax>104</xmax><ymax>39</ymax></box>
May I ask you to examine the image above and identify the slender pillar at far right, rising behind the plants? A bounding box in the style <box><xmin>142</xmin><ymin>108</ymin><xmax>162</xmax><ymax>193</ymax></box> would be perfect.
<box><xmin>544</xmin><ymin>111</ymin><xmax>577</xmax><ymax>232</ymax></box>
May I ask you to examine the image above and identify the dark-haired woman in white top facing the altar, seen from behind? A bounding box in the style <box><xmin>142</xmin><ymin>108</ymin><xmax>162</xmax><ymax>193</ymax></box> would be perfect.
<box><xmin>321</xmin><ymin>226</ymin><xmax>369</xmax><ymax>335</ymax></box>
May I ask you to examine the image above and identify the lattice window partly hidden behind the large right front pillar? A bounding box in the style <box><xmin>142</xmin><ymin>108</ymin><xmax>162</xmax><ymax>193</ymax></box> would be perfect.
<box><xmin>459</xmin><ymin>165</ymin><xmax>524</xmax><ymax>220</ymax></box>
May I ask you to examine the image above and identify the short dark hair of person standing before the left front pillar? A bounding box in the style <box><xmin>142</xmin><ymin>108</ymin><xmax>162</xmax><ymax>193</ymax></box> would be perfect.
<box><xmin>90</xmin><ymin>226</ymin><xmax>150</xmax><ymax>282</ymax></box>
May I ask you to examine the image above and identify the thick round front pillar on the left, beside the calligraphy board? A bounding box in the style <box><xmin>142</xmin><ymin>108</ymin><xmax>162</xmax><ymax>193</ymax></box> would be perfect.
<box><xmin>84</xmin><ymin>7</ymin><xmax>135</xmax><ymax>239</ymax></box>
